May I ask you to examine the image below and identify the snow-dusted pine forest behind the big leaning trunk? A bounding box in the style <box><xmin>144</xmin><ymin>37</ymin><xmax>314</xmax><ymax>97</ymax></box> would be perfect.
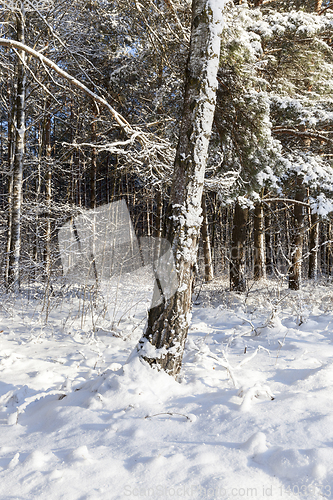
<box><xmin>0</xmin><ymin>0</ymin><xmax>333</xmax><ymax>372</ymax></box>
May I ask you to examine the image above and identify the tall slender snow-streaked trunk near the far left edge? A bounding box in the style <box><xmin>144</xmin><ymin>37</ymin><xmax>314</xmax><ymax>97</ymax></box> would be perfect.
<box><xmin>8</xmin><ymin>12</ymin><xmax>26</xmax><ymax>291</ymax></box>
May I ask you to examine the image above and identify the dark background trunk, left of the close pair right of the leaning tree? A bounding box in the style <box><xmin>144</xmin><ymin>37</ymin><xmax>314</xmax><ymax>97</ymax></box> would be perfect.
<box><xmin>230</xmin><ymin>202</ymin><xmax>248</xmax><ymax>292</ymax></box>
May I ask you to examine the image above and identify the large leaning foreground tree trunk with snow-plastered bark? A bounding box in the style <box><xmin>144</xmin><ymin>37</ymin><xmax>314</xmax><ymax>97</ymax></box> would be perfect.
<box><xmin>138</xmin><ymin>0</ymin><xmax>223</xmax><ymax>376</ymax></box>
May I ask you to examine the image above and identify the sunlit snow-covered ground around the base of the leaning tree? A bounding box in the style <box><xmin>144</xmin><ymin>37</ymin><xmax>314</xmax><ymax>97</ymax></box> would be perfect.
<box><xmin>0</xmin><ymin>282</ymin><xmax>333</xmax><ymax>500</ymax></box>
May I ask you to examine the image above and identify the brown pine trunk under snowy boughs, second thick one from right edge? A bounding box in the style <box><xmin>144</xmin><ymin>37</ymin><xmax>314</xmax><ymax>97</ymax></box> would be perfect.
<box><xmin>289</xmin><ymin>176</ymin><xmax>305</xmax><ymax>290</ymax></box>
